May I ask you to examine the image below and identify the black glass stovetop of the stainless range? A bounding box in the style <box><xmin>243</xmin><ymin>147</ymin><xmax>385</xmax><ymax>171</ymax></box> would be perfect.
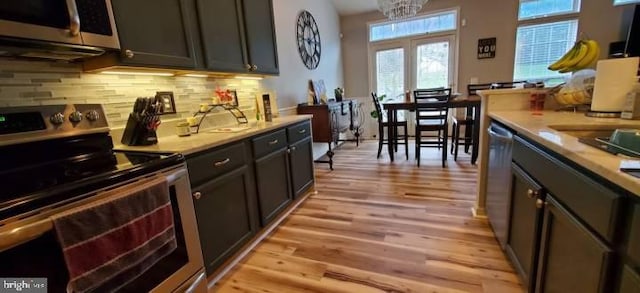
<box><xmin>0</xmin><ymin>133</ymin><xmax>184</xmax><ymax>221</ymax></box>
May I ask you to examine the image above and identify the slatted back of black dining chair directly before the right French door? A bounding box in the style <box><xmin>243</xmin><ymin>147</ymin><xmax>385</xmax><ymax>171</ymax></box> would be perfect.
<box><xmin>413</xmin><ymin>88</ymin><xmax>451</xmax><ymax>125</ymax></box>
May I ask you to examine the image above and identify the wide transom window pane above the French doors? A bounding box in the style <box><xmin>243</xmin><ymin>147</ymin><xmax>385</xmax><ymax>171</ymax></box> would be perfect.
<box><xmin>369</xmin><ymin>11</ymin><xmax>456</xmax><ymax>42</ymax></box>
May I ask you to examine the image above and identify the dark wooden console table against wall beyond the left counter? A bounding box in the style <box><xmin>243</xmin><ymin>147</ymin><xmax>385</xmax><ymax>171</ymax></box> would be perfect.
<box><xmin>298</xmin><ymin>100</ymin><xmax>362</xmax><ymax>170</ymax></box>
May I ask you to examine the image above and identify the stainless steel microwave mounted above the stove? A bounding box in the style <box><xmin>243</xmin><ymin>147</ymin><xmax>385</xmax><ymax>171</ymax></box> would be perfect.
<box><xmin>0</xmin><ymin>0</ymin><xmax>120</xmax><ymax>59</ymax></box>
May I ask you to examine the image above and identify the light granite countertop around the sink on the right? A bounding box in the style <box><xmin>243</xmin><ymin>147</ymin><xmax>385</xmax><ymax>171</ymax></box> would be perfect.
<box><xmin>489</xmin><ymin>110</ymin><xmax>640</xmax><ymax>195</ymax></box>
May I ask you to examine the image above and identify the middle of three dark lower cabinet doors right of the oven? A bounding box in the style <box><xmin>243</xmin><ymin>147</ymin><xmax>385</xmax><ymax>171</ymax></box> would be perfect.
<box><xmin>256</xmin><ymin>149</ymin><xmax>291</xmax><ymax>226</ymax></box>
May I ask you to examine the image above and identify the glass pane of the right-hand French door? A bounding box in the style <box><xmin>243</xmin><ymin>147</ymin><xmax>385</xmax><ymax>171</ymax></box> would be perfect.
<box><xmin>416</xmin><ymin>42</ymin><xmax>449</xmax><ymax>89</ymax></box>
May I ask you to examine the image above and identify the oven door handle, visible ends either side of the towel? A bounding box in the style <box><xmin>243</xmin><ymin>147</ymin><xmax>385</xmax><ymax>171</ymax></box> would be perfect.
<box><xmin>0</xmin><ymin>168</ymin><xmax>187</xmax><ymax>252</ymax></box>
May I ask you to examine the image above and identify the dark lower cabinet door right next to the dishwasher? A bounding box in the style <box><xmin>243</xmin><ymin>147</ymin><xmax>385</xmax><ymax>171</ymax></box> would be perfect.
<box><xmin>506</xmin><ymin>164</ymin><xmax>543</xmax><ymax>292</ymax></box>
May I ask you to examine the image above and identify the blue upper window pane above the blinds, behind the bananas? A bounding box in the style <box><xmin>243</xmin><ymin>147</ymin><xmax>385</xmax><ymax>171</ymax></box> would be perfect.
<box><xmin>518</xmin><ymin>0</ymin><xmax>580</xmax><ymax>20</ymax></box>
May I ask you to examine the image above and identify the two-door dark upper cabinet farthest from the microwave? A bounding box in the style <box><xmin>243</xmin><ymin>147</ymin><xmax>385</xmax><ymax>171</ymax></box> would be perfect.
<box><xmin>196</xmin><ymin>0</ymin><xmax>279</xmax><ymax>74</ymax></box>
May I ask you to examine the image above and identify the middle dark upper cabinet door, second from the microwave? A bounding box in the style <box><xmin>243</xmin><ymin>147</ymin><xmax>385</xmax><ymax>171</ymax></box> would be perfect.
<box><xmin>196</xmin><ymin>0</ymin><xmax>248</xmax><ymax>72</ymax></box>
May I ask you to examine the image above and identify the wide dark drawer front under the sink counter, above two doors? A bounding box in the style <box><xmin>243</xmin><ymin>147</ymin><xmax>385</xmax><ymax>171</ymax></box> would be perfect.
<box><xmin>513</xmin><ymin>136</ymin><xmax>621</xmax><ymax>241</ymax></box>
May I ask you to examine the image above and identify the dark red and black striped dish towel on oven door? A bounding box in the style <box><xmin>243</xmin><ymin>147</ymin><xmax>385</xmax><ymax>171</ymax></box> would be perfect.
<box><xmin>52</xmin><ymin>179</ymin><xmax>177</xmax><ymax>292</ymax></box>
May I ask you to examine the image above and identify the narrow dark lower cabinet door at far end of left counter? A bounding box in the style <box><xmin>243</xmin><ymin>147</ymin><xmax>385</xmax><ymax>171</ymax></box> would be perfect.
<box><xmin>289</xmin><ymin>137</ymin><xmax>313</xmax><ymax>197</ymax></box>
